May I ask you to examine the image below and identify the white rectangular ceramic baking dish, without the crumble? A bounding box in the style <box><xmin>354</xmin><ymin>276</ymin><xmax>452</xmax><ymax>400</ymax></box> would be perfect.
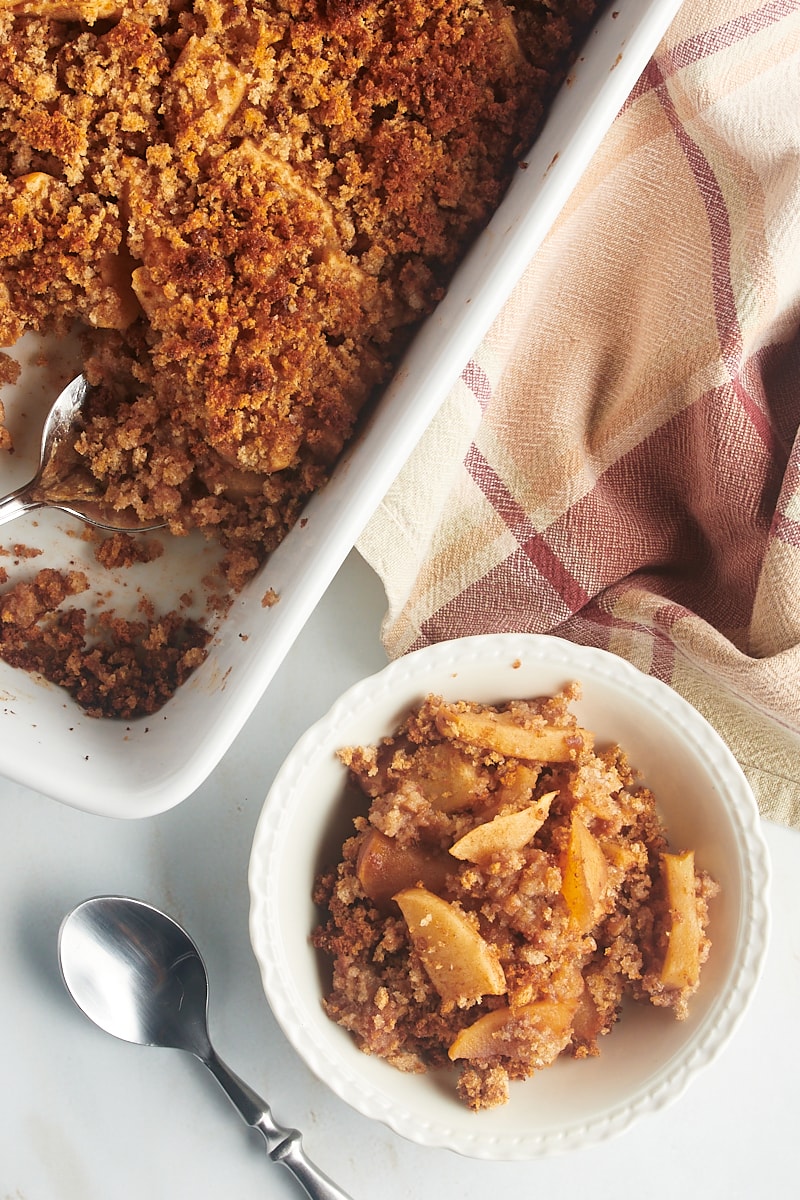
<box><xmin>0</xmin><ymin>0</ymin><xmax>680</xmax><ymax>817</ymax></box>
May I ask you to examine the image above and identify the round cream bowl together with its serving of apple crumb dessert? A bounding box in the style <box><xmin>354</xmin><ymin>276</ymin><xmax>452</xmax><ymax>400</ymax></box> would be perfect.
<box><xmin>249</xmin><ymin>634</ymin><xmax>769</xmax><ymax>1159</ymax></box>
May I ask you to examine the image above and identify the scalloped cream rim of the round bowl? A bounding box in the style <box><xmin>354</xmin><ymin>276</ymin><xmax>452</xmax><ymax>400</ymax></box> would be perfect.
<box><xmin>248</xmin><ymin>634</ymin><xmax>770</xmax><ymax>1160</ymax></box>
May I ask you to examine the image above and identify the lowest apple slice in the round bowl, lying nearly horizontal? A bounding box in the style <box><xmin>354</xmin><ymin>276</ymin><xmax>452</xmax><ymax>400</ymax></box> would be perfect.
<box><xmin>447</xmin><ymin>1000</ymin><xmax>576</xmax><ymax>1066</ymax></box>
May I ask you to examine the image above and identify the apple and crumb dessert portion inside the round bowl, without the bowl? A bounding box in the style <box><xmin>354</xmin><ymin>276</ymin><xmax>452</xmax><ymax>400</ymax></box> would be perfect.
<box><xmin>313</xmin><ymin>685</ymin><xmax>718</xmax><ymax>1109</ymax></box>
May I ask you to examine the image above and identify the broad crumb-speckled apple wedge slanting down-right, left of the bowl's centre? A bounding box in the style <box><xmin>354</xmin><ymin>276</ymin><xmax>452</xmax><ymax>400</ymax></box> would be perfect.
<box><xmin>395</xmin><ymin>888</ymin><xmax>506</xmax><ymax>1004</ymax></box>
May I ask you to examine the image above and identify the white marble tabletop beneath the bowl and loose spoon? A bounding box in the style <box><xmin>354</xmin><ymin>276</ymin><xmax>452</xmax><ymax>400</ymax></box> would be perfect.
<box><xmin>0</xmin><ymin>553</ymin><xmax>800</xmax><ymax>1200</ymax></box>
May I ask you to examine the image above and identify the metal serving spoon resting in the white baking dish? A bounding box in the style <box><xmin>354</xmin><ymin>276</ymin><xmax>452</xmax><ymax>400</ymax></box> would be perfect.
<box><xmin>0</xmin><ymin>376</ymin><xmax>166</xmax><ymax>533</ymax></box>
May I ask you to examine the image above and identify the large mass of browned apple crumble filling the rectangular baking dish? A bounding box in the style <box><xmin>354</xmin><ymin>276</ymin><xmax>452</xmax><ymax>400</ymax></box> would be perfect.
<box><xmin>0</xmin><ymin>0</ymin><xmax>597</xmax><ymax>710</ymax></box>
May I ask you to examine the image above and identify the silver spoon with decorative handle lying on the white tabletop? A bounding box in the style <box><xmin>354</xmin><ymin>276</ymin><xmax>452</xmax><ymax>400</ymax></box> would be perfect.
<box><xmin>59</xmin><ymin>896</ymin><xmax>349</xmax><ymax>1200</ymax></box>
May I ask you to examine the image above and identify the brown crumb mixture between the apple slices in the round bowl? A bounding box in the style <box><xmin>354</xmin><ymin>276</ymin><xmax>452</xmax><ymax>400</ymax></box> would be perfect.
<box><xmin>313</xmin><ymin>689</ymin><xmax>717</xmax><ymax>1109</ymax></box>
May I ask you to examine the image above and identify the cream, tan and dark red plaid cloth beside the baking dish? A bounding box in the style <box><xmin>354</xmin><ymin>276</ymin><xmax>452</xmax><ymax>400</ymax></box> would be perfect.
<box><xmin>359</xmin><ymin>0</ymin><xmax>800</xmax><ymax>827</ymax></box>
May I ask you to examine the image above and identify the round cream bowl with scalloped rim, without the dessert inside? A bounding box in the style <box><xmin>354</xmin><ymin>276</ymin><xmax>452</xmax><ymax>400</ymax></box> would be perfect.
<box><xmin>249</xmin><ymin>634</ymin><xmax>769</xmax><ymax>1159</ymax></box>
